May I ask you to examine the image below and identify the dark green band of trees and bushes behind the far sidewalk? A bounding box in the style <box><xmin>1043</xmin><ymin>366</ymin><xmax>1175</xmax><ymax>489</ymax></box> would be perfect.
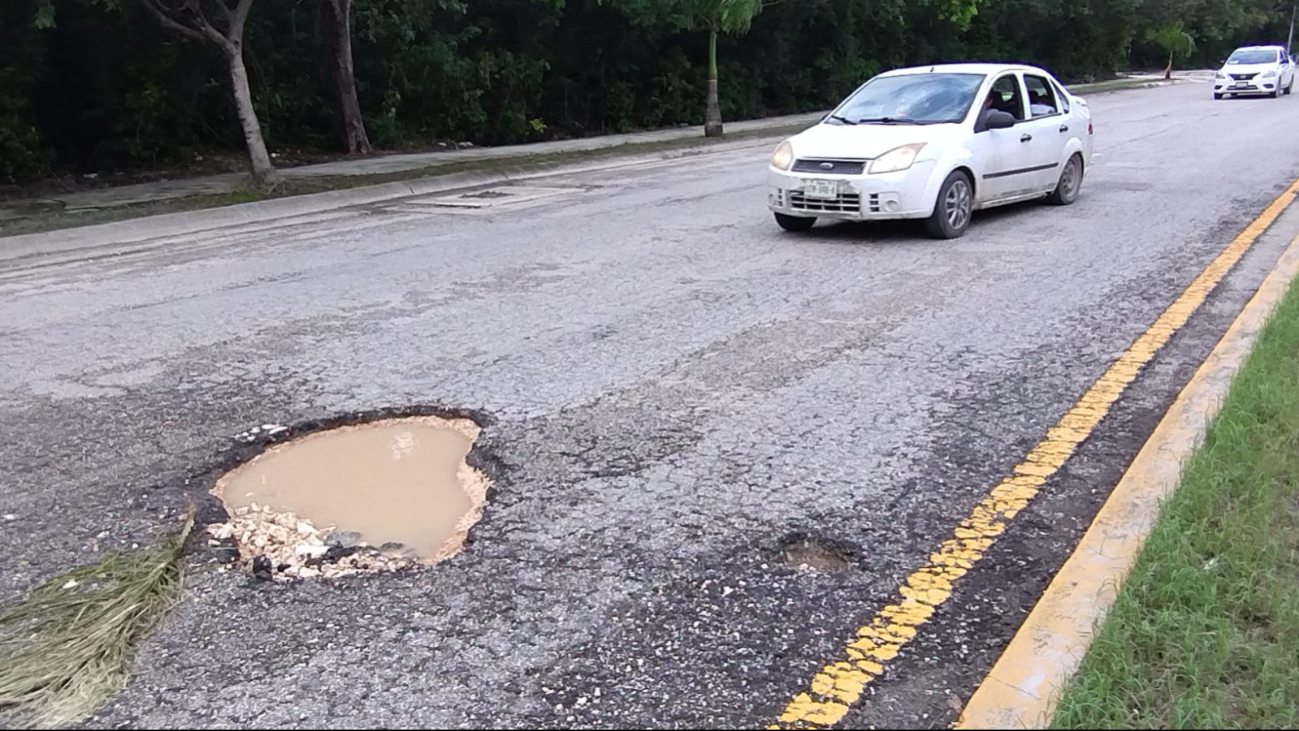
<box><xmin>0</xmin><ymin>0</ymin><xmax>1289</xmax><ymax>192</ymax></box>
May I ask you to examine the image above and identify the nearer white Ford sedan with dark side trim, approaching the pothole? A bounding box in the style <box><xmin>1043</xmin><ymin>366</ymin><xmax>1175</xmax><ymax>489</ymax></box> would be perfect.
<box><xmin>766</xmin><ymin>64</ymin><xmax>1092</xmax><ymax>239</ymax></box>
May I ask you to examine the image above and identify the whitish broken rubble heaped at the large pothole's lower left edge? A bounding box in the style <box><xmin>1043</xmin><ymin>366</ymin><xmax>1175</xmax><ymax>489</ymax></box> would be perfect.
<box><xmin>208</xmin><ymin>505</ymin><xmax>417</xmax><ymax>582</ymax></box>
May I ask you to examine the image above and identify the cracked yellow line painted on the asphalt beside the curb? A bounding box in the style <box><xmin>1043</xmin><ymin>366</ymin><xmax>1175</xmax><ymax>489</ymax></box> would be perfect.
<box><xmin>772</xmin><ymin>180</ymin><xmax>1299</xmax><ymax>728</ymax></box>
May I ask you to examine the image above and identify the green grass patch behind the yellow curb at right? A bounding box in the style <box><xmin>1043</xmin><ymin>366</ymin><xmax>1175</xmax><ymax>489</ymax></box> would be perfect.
<box><xmin>1052</xmin><ymin>277</ymin><xmax>1299</xmax><ymax>728</ymax></box>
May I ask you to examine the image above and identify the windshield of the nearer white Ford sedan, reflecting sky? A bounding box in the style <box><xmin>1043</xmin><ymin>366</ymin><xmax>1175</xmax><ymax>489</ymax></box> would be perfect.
<box><xmin>829</xmin><ymin>74</ymin><xmax>983</xmax><ymax>125</ymax></box>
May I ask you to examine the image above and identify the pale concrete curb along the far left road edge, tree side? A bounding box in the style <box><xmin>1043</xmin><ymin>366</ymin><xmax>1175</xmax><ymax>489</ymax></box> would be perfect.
<box><xmin>0</xmin><ymin>126</ymin><xmax>795</xmax><ymax>262</ymax></box>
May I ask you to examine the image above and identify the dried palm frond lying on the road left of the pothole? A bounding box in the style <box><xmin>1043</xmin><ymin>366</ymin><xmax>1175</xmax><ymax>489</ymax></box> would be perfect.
<box><xmin>0</xmin><ymin>512</ymin><xmax>194</xmax><ymax>727</ymax></box>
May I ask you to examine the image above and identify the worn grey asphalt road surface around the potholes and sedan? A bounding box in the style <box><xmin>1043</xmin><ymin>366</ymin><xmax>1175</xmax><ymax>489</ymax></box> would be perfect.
<box><xmin>0</xmin><ymin>77</ymin><xmax>1299</xmax><ymax>728</ymax></box>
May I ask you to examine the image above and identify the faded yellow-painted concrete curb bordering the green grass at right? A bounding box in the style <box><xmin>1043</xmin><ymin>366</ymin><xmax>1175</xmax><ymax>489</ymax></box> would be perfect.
<box><xmin>956</xmin><ymin>223</ymin><xmax>1299</xmax><ymax>728</ymax></box>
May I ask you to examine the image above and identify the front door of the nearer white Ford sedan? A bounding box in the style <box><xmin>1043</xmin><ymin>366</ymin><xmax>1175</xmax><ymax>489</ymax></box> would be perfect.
<box><xmin>968</xmin><ymin>73</ymin><xmax>1026</xmax><ymax>205</ymax></box>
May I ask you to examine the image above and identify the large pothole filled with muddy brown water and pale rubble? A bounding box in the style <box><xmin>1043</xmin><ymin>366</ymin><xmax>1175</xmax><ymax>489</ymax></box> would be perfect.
<box><xmin>208</xmin><ymin>417</ymin><xmax>487</xmax><ymax>580</ymax></box>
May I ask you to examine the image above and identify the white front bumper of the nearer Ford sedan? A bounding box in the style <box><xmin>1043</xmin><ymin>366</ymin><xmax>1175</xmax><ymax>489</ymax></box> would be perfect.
<box><xmin>766</xmin><ymin>161</ymin><xmax>935</xmax><ymax>221</ymax></box>
